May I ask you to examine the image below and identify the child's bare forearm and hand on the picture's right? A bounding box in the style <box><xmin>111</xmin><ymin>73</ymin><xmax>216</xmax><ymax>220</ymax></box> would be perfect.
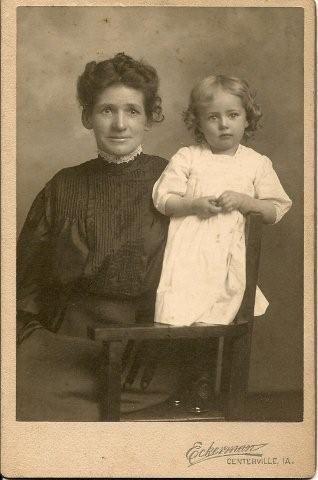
<box><xmin>218</xmin><ymin>190</ymin><xmax>276</xmax><ymax>223</ymax></box>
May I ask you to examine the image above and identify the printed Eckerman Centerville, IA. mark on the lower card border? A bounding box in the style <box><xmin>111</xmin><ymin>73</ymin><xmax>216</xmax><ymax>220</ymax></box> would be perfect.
<box><xmin>186</xmin><ymin>441</ymin><xmax>293</xmax><ymax>467</ymax></box>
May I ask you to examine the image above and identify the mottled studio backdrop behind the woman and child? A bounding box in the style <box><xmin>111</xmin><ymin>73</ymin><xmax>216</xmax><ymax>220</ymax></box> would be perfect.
<box><xmin>17</xmin><ymin>7</ymin><xmax>303</xmax><ymax>391</ymax></box>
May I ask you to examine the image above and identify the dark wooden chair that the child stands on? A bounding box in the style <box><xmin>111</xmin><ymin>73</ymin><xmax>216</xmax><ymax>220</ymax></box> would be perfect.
<box><xmin>88</xmin><ymin>214</ymin><xmax>262</xmax><ymax>421</ymax></box>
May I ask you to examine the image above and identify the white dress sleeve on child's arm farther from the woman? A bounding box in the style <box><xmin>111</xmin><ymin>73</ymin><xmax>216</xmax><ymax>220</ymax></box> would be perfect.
<box><xmin>254</xmin><ymin>156</ymin><xmax>292</xmax><ymax>223</ymax></box>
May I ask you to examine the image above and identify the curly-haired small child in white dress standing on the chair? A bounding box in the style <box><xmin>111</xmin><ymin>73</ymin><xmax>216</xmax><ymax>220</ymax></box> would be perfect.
<box><xmin>153</xmin><ymin>75</ymin><xmax>292</xmax><ymax>413</ymax></box>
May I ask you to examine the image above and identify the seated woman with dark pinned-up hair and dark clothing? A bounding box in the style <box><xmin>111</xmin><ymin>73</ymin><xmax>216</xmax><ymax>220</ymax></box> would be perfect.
<box><xmin>17</xmin><ymin>53</ymin><xmax>168</xmax><ymax>421</ymax></box>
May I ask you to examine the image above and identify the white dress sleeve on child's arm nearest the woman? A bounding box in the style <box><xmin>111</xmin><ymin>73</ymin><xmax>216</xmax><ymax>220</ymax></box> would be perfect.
<box><xmin>152</xmin><ymin>147</ymin><xmax>191</xmax><ymax>214</ymax></box>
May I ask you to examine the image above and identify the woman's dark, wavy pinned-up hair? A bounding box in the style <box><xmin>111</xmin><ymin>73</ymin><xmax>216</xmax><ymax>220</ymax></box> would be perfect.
<box><xmin>77</xmin><ymin>53</ymin><xmax>164</xmax><ymax>122</ymax></box>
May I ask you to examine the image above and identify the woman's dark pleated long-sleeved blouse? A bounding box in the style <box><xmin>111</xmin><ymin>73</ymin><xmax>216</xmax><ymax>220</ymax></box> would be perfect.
<box><xmin>17</xmin><ymin>153</ymin><xmax>168</xmax><ymax>338</ymax></box>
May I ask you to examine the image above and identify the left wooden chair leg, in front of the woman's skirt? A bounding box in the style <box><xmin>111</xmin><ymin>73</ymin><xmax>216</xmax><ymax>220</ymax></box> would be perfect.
<box><xmin>100</xmin><ymin>341</ymin><xmax>123</xmax><ymax>422</ymax></box>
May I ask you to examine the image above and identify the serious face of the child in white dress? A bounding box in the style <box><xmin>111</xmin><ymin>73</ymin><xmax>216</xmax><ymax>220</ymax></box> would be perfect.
<box><xmin>198</xmin><ymin>87</ymin><xmax>248</xmax><ymax>155</ymax></box>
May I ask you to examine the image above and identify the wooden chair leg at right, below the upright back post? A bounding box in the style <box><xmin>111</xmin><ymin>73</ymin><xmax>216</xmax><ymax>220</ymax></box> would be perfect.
<box><xmin>222</xmin><ymin>335</ymin><xmax>250</xmax><ymax>420</ymax></box>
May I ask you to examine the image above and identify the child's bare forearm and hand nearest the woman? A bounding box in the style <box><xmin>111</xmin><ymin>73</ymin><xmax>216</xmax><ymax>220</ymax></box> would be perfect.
<box><xmin>165</xmin><ymin>194</ymin><xmax>222</xmax><ymax>218</ymax></box>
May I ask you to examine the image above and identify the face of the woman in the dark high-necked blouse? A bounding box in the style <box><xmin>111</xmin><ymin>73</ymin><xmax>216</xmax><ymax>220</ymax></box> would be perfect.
<box><xmin>84</xmin><ymin>84</ymin><xmax>149</xmax><ymax>156</ymax></box>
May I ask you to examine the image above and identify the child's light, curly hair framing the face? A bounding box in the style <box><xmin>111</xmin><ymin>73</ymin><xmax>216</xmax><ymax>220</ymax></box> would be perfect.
<box><xmin>183</xmin><ymin>75</ymin><xmax>262</xmax><ymax>143</ymax></box>
